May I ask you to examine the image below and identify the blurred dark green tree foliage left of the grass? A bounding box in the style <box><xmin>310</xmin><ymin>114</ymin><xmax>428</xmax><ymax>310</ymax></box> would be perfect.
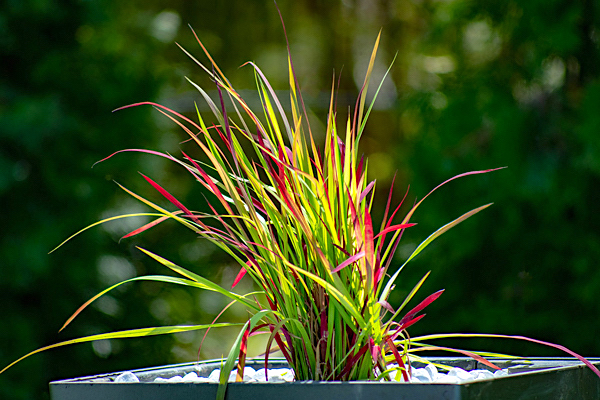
<box><xmin>0</xmin><ymin>1</ymin><xmax>171</xmax><ymax>399</ymax></box>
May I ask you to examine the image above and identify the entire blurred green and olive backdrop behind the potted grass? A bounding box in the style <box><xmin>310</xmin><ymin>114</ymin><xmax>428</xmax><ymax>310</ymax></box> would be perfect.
<box><xmin>0</xmin><ymin>0</ymin><xmax>600</xmax><ymax>399</ymax></box>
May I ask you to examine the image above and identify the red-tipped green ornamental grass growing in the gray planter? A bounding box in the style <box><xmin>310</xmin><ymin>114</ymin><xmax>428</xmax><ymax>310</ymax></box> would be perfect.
<box><xmin>0</xmin><ymin>20</ymin><xmax>600</xmax><ymax>398</ymax></box>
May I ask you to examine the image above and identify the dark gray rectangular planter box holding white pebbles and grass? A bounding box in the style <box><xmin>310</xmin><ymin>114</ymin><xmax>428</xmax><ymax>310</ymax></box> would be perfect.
<box><xmin>50</xmin><ymin>357</ymin><xmax>600</xmax><ymax>400</ymax></box>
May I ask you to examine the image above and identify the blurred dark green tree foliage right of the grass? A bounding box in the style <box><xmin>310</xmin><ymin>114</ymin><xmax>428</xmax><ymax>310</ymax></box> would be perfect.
<box><xmin>384</xmin><ymin>1</ymin><xmax>600</xmax><ymax>355</ymax></box>
